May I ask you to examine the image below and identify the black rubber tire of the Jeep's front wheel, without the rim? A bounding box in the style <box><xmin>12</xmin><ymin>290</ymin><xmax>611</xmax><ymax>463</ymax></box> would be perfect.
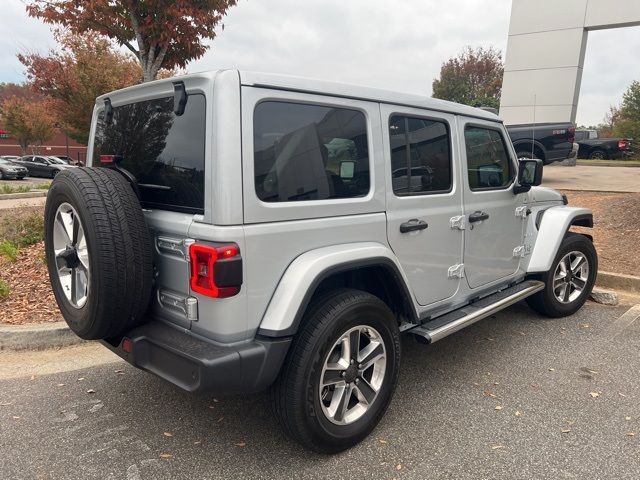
<box><xmin>527</xmin><ymin>232</ymin><xmax>598</xmax><ymax>318</ymax></box>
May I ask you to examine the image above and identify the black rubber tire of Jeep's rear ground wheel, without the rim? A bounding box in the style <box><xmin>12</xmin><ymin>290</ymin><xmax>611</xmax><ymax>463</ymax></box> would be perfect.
<box><xmin>271</xmin><ymin>289</ymin><xmax>400</xmax><ymax>453</ymax></box>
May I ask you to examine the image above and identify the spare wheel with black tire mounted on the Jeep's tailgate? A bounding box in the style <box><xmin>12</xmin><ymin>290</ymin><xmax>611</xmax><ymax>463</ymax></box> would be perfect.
<box><xmin>44</xmin><ymin>168</ymin><xmax>153</xmax><ymax>340</ymax></box>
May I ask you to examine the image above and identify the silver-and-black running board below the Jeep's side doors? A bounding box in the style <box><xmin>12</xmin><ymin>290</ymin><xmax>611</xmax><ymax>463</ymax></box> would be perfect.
<box><xmin>408</xmin><ymin>280</ymin><xmax>544</xmax><ymax>343</ymax></box>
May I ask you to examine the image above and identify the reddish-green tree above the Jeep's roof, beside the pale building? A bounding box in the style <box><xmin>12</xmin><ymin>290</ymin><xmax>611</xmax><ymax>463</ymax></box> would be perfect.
<box><xmin>433</xmin><ymin>47</ymin><xmax>504</xmax><ymax>108</ymax></box>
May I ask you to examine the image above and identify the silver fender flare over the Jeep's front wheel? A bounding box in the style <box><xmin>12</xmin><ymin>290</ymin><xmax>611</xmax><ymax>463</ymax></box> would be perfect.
<box><xmin>527</xmin><ymin>206</ymin><xmax>593</xmax><ymax>273</ymax></box>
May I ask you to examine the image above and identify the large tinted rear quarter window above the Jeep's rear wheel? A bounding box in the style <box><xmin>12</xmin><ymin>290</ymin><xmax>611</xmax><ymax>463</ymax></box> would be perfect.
<box><xmin>253</xmin><ymin>102</ymin><xmax>369</xmax><ymax>202</ymax></box>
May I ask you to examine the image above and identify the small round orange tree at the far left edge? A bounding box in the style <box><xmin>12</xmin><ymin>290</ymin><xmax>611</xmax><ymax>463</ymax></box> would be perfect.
<box><xmin>0</xmin><ymin>97</ymin><xmax>55</xmax><ymax>153</ymax></box>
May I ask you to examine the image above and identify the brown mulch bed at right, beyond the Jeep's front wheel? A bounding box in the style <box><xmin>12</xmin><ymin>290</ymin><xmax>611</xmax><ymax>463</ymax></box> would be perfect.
<box><xmin>563</xmin><ymin>191</ymin><xmax>640</xmax><ymax>275</ymax></box>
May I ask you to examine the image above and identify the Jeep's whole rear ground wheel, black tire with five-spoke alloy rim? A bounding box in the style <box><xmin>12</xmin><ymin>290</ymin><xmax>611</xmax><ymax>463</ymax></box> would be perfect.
<box><xmin>271</xmin><ymin>290</ymin><xmax>400</xmax><ymax>453</ymax></box>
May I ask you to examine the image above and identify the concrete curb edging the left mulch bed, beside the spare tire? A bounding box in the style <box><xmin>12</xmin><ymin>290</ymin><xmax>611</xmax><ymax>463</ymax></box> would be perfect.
<box><xmin>0</xmin><ymin>322</ymin><xmax>84</xmax><ymax>350</ymax></box>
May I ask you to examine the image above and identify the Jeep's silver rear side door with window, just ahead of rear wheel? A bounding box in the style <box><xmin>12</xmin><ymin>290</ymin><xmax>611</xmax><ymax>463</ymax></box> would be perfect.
<box><xmin>381</xmin><ymin>105</ymin><xmax>463</xmax><ymax>305</ymax></box>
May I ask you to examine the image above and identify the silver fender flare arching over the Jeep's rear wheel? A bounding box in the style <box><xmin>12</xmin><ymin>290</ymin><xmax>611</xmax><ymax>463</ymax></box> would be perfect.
<box><xmin>258</xmin><ymin>242</ymin><xmax>417</xmax><ymax>337</ymax></box>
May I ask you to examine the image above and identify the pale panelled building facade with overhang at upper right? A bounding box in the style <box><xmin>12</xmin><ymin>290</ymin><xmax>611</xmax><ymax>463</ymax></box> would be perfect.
<box><xmin>500</xmin><ymin>0</ymin><xmax>640</xmax><ymax>125</ymax></box>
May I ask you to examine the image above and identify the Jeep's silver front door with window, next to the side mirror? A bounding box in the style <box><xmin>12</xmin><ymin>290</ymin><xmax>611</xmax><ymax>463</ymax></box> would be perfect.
<box><xmin>459</xmin><ymin>119</ymin><xmax>526</xmax><ymax>288</ymax></box>
